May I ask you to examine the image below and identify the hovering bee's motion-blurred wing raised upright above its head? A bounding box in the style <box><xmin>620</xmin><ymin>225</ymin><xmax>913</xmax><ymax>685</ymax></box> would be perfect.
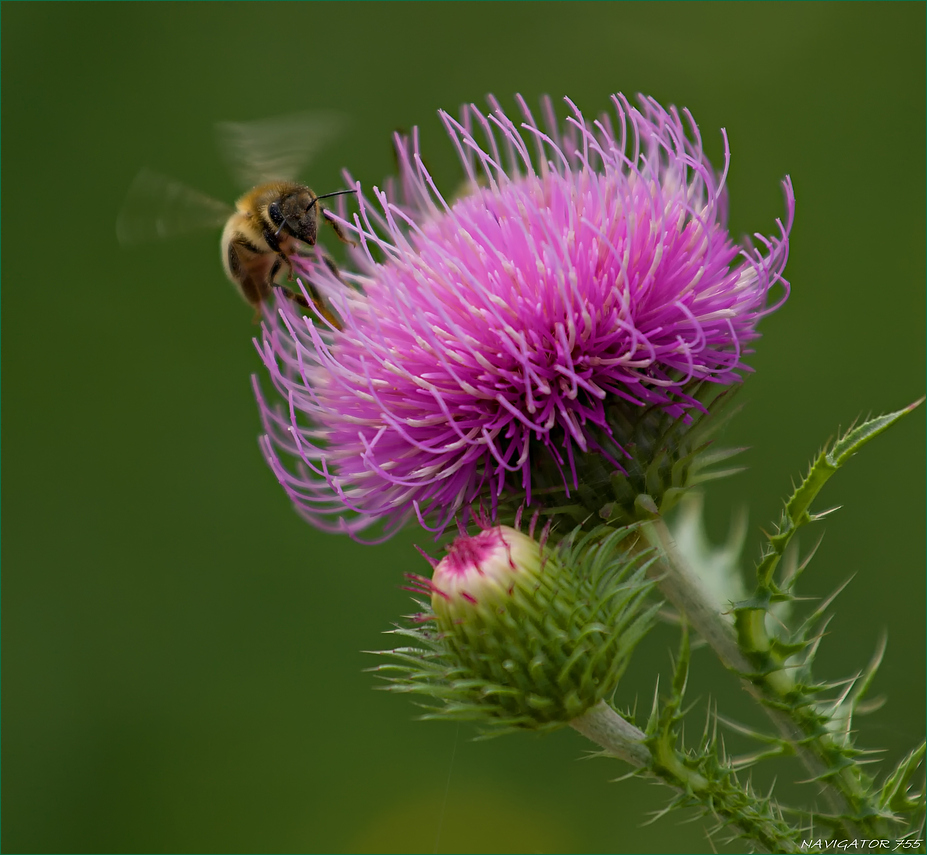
<box><xmin>216</xmin><ymin>112</ymin><xmax>347</xmax><ymax>189</ymax></box>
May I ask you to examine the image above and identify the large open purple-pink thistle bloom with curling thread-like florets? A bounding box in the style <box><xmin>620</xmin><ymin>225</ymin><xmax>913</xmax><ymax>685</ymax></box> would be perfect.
<box><xmin>258</xmin><ymin>90</ymin><xmax>794</xmax><ymax>533</ymax></box>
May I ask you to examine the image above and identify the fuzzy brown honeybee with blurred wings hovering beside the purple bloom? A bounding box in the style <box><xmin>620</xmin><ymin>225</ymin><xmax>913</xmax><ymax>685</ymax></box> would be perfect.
<box><xmin>116</xmin><ymin>113</ymin><xmax>356</xmax><ymax>329</ymax></box>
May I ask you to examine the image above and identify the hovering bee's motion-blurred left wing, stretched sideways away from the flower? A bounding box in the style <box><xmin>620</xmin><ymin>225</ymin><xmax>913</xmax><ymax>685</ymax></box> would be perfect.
<box><xmin>116</xmin><ymin>169</ymin><xmax>233</xmax><ymax>244</ymax></box>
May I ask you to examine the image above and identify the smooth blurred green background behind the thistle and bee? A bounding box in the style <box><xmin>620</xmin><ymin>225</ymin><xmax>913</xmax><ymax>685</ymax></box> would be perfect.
<box><xmin>2</xmin><ymin>3</ymin><xmax>925</xmax><ymax>852</ymax></box>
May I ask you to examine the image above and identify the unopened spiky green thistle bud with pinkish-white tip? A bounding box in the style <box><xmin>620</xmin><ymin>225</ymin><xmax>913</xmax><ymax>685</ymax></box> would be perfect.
<box><xmin>377</xmin><ymin>526</ymin><xmax>657</xmax><ymax>730</ymax></box>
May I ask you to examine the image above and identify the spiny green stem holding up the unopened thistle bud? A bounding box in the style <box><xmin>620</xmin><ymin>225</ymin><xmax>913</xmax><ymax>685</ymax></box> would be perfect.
<box><xmin>570</xmin><ymin>701</ymin><xmax>802</xmax><ymax>853</ymax></box>
